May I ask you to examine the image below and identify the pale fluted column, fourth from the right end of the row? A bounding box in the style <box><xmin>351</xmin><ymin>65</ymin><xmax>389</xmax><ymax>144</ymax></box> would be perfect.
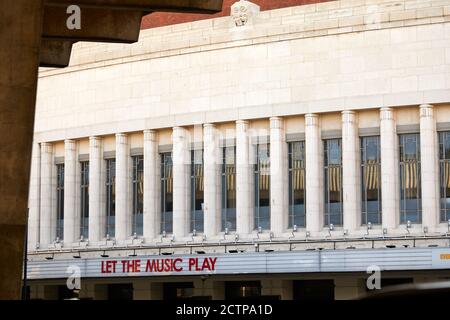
<box><xmin>305</xmin><ymin>114</ymin><xmax>324</xmax><ymax>232</ymax></box>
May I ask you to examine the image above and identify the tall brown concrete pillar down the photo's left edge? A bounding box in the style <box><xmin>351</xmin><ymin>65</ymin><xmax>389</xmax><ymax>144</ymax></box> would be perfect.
<box><xmin>0</xmin><ymin>0</ymin><xmax>44</xmax><ymax>300</ymax></box>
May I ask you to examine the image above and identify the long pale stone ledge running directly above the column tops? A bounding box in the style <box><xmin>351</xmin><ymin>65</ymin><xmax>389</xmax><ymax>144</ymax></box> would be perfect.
<box><xmin>34</xmin><ymin>90</ymin><xmax>450</xmax><ymax>142</ymax></box>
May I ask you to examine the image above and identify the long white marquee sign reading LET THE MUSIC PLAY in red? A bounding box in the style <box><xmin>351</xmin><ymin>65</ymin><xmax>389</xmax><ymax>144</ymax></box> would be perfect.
<box><xmin>28</xmin><ymin>247</ymin><xmax>450</xmax><ymax>279</ymax></box>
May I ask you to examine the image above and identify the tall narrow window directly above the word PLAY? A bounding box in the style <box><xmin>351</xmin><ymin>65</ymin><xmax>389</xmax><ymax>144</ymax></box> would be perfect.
<box><xmin>191</xmin><ymin>150</ymin><xmax>203</xmax><ymax>232</ymax></box>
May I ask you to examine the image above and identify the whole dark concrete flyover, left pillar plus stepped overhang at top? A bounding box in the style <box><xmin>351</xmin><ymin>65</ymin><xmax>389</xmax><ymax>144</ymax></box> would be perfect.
<box><xmin>0</xmin><ymin>0</ymin><xmax>222</xmax><ymax>299</ymax></box>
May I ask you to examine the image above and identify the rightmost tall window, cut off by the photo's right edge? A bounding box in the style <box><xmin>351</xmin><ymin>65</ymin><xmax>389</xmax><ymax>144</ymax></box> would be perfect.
<box><xmin>439</xmin><ymin>131</ymin><xmax>450</xmax><ymax>222</ymax></box>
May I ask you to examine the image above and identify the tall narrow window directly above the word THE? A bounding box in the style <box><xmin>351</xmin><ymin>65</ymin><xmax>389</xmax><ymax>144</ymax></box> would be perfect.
<box><xmin>131</xmin><ymin>156</ymin><xmax>144</xmax><ymax>236</ymax></box>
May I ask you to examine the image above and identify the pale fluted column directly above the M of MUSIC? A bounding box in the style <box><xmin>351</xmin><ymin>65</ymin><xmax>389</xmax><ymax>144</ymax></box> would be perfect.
<box><xmin>144</xmin><ymin>130</ymin><xmax>160</xmax><ymax>241</ymax></box>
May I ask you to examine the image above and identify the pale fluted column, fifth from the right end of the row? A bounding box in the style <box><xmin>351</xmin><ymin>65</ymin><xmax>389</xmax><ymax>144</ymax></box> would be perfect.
<box><xmin>270</xmin><ymin>117</ymin><xmax>289</xmax><ymax>234</ymax></box>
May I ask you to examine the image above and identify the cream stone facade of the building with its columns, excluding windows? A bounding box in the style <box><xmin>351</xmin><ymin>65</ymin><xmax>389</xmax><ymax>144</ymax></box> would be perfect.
<box><xmin>29</xmin><ymin>0</ymin><xmax>450</xmax><ymax>300</ymax></box>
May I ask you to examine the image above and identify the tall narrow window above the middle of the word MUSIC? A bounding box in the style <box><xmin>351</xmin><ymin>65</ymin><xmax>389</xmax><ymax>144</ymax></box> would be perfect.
<box><xmin>161</xmin><ymin>152</ymin><xmax>173</xmax><ymax>233</ymax></box>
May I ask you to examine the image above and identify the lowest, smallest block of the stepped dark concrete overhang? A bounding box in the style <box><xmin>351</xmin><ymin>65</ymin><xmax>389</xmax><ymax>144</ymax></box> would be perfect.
<box><xmin>39</xmin><ymin>39</ymin><xmax>73</xmax><ymax>68</ymax></box>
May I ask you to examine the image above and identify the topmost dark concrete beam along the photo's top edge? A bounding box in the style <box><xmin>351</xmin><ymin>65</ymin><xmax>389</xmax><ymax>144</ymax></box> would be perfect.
<box><xmin>46</xmin><ymin>0</ymin><xmax>223</xmax><ymax>13</ymax></box>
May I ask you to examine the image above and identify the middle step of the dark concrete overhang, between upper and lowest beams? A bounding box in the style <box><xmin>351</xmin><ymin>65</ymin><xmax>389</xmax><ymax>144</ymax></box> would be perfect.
<box><xmin>42</xmin><ymin>6</ymin><xmax>144</xmax><ymax>43</ymax></box>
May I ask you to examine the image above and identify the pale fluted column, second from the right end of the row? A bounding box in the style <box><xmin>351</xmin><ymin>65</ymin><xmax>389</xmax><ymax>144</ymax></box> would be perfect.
<box><xmin>380</xmin><ymin>108</ymin><xmax>400</xmax><ymax>230</ymax></box>
